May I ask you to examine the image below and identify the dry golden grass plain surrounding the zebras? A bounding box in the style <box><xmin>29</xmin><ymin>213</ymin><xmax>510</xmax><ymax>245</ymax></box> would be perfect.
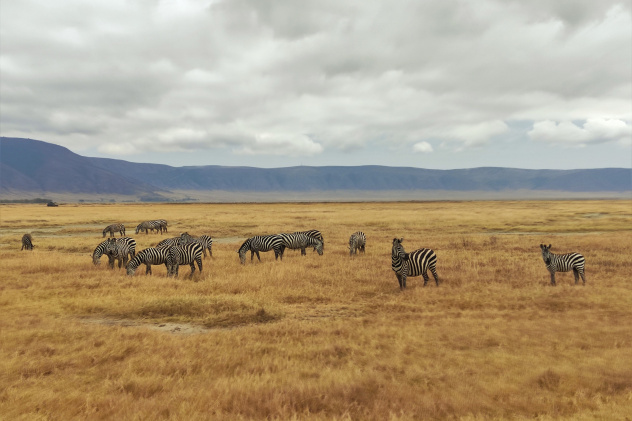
<box><xmin>0</xmin><ymin>200</ymin><xmax>632</xmax><ymax>420</ymax></box>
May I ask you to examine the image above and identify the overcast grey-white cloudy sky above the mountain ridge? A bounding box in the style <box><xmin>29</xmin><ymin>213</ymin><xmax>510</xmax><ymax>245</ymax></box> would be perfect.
<box><xmin>0</xmin><ymin>0</ymin><xmax>632</xmax><ymax>169</ymax></box>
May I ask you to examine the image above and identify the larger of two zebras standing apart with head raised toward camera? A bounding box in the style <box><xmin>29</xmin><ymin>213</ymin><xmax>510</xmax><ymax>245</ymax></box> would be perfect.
<box><xmin>391</xmin><ymin>238</ymin><xmax>439</xmax><ymax>290</ymax></box>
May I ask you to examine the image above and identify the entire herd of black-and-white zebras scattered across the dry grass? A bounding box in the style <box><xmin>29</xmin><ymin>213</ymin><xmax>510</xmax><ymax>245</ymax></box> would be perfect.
<box><xmin>20</xmin><ymin>219</ymin><xmax>586</xmax><ymax>290</ymax></box>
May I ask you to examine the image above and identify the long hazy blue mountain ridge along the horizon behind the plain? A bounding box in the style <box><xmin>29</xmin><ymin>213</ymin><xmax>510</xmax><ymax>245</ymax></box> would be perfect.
<box><xmin>0</xmin><ymin>137</ymin><xmax>632</xmax><ymax>197</ymax></box>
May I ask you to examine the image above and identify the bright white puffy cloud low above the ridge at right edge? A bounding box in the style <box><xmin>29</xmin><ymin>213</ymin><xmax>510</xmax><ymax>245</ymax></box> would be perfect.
<box><xmin>528</xmin><ymin>118</ymin><xmax>632</xmax><ymax>146</ymax></box>
